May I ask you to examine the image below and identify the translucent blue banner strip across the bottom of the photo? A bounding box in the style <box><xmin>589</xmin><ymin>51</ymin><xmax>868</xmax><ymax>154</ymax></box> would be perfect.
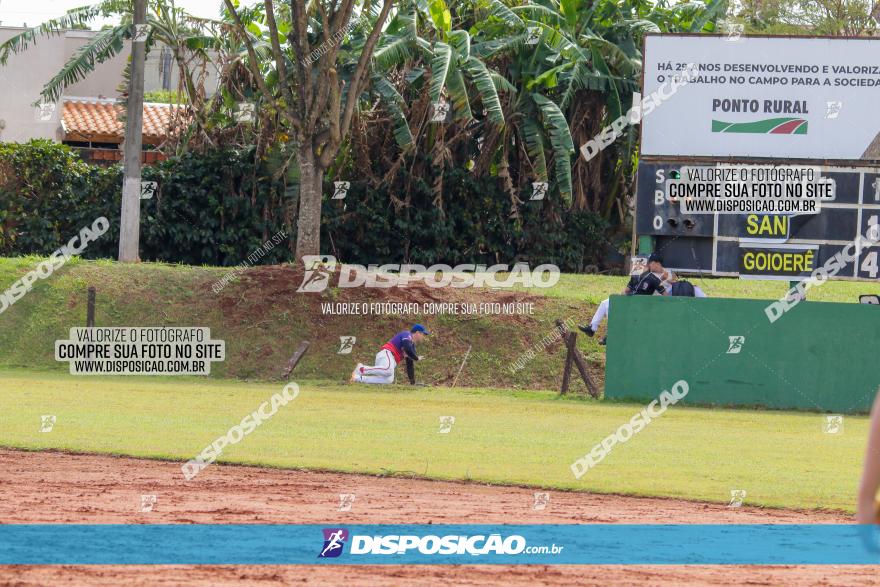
<box><xmin>0</xmin><ymin>524</ymin><xmax>880</xmax><ymax>565</ymax></box>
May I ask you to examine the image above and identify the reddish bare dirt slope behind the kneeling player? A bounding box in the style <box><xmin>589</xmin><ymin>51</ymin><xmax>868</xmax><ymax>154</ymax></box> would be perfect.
<box><xmin>210</xmin><ymin>266</ymin><xmax>592</xmax><ymax>391</ymax></box>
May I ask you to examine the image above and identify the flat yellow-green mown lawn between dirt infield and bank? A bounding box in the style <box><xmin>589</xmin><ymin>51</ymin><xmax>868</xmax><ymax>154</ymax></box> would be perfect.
<box><xmin>0</xmin><ymin>370</ymin><xmax>867</xmax><ymax>511</ymax></box>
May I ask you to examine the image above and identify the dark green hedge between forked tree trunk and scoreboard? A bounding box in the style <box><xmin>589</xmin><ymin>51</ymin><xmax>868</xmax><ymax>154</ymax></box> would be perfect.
<box><xmin>322</xmin><ymin>161</ymin><xmax>607</xmax><ymax>271</ymax></box>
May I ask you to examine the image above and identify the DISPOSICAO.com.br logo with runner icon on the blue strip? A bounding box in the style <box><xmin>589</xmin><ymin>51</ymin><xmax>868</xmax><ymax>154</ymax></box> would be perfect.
<box><xmin>318</xmin><ymin>528</ymin><xmax>565</xmax><ymax>558</ymax></box>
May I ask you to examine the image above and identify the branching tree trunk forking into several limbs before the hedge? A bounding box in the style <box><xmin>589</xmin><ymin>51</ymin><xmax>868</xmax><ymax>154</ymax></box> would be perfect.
<box><xmin>224</xmin><ymin>0</ymin><xmax>393</xmax><ymax>260</ymax></box>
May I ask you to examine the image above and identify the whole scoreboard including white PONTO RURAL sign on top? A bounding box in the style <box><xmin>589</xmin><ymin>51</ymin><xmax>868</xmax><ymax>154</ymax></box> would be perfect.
<box><xmin>634</xmin><ymin>33</ymin><xmax>880</xmax><ymax>281</ymax></box>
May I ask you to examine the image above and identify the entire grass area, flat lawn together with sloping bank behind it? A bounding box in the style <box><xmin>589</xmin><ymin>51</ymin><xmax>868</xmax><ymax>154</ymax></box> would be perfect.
<box><xmin>0</xmin><ymin>257</ymin><xmax>880</xmax><ymax>511</ymax></box>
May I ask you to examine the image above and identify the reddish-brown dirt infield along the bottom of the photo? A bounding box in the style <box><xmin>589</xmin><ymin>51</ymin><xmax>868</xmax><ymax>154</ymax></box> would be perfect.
<box><xmin>0</xmin><ymin>450</ymin><xmax>877</xmax><ymax>585</ymax></box>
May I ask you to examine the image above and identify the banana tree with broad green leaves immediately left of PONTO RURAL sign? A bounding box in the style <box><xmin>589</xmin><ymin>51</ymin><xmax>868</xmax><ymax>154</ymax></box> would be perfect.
<box><xmin>476</xmin><ymin>0</ymin><xmax>725</xmax><ymax>220</ymax></box>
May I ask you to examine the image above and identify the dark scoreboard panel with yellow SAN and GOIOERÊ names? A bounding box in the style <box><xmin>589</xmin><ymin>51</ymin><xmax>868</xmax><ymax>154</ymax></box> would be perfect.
<box><xmin>636</xmin><ymin>161</ymin><xmax>880</xmax><ymax>280</ymax></box>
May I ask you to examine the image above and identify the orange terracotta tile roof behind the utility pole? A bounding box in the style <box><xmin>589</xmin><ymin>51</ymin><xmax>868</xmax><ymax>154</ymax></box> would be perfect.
<box><xmin>61</xmin><ymin>99</ymin><xmax>186</xmax><ymax>144</ymax></box>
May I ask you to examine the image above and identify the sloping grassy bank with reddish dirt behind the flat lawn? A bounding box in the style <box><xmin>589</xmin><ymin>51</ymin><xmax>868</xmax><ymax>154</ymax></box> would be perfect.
<box><xmin>0</xmin><ymin>257</ymin><xmax>880</xmax><ymax>389</ymax></box>
